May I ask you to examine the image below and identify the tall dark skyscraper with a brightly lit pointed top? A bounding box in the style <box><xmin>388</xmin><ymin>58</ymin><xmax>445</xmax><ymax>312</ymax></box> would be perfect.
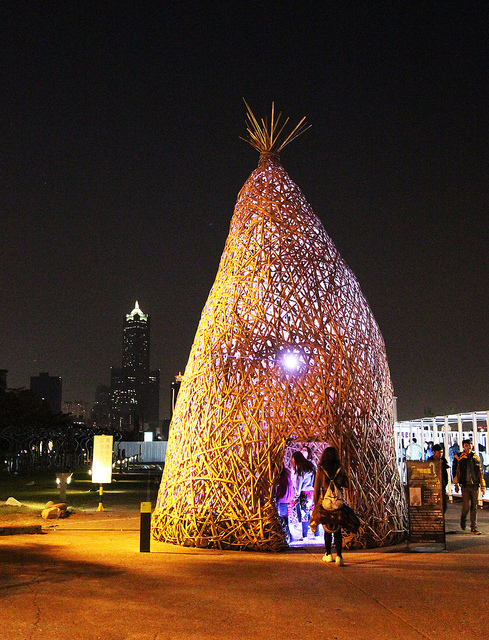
<box><xmin>110</xmin><ymin>301</ymin><xmax>160</xmax><ymax>440</ymax></box>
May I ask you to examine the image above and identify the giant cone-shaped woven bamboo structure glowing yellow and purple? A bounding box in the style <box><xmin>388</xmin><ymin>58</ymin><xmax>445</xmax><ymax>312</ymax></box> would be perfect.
<box><xmin>153</xmin><ymin>104</ymin><xmax>406</xmax><ymax>550</ymax></box>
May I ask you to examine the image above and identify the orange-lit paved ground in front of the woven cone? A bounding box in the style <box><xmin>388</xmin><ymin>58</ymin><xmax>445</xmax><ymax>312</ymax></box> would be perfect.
<box><xmin>0</xmin><ymin>504</ymin><xmax>489</xmax><ymax>640</ymax></box>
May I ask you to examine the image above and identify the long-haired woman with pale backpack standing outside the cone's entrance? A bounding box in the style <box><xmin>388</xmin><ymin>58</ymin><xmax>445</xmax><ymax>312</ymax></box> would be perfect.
<box><xmin>314</xmin><ymin>447</ymin><xmax>349</xmax><ymax>566</ymax></box>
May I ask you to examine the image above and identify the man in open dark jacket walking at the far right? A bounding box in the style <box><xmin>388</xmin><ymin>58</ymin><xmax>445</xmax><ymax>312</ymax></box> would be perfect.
<box><xmin>452</xmin><ymin>440</ymin><xmax>486</xmax><ymax>535</ymax></box>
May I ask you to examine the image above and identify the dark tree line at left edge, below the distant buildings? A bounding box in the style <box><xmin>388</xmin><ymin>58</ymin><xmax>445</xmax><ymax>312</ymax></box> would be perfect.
<box><xmin>0</xmin><ymin>389</ymin><xmax>120</xmax><ymax>473</ymax></box>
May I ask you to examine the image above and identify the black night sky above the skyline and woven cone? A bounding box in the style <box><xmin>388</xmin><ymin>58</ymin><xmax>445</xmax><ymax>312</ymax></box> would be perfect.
<box><xmin>0</xmin><ymin>0</ymin><xmax>489</xmax><ymax>419</ymax></box>
